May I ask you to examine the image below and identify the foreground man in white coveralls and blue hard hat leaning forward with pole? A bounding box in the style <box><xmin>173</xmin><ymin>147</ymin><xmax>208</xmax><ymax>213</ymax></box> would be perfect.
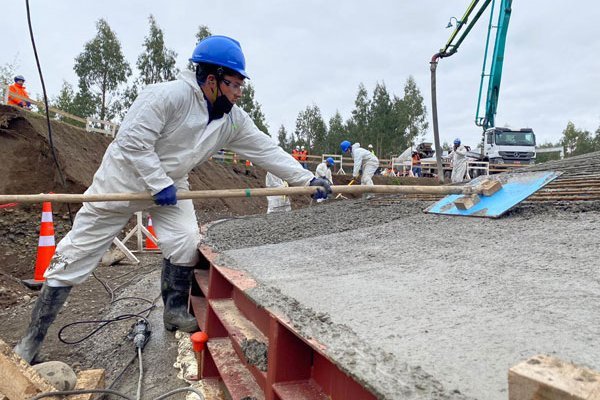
<box><xmin>15</xmin><ymin>36</ymin><xmax>331</xmax><ymax>362</ymax></box>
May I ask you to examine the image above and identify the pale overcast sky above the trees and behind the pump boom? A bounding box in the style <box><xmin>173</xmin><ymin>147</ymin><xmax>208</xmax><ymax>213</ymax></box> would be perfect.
<box><xmin>0</xmin><ymin>0</ymin><xmax>600</xmax><ymax>150</ymax></box>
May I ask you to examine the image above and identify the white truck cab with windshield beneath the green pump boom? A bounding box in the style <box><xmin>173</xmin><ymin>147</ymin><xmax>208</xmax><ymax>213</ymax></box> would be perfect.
<box><xmin>483</xmin><ymin>127</ymin><xmax>535</xmax><ymax>164</ymax></box>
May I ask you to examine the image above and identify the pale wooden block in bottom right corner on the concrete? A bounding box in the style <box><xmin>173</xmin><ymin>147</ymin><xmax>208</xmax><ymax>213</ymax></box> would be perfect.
<box><xmin>508</xmin><ymin>355</ymin><xmax>600</xmax><ymax>400</ymax></box>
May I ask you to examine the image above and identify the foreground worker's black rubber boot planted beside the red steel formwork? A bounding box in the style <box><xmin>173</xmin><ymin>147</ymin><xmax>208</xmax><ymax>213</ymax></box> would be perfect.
<box><xmin>161</xmin><ymin>260</ymin><xmax>199</xmax><ymax>332</ymax></box>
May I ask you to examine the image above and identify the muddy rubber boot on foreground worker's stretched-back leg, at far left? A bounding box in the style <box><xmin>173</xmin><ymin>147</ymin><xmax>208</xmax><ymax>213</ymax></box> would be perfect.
<box><xmin>14</xmin><ymin>284</ymin><xmax>71</xmax><ymax>363</ymax></box>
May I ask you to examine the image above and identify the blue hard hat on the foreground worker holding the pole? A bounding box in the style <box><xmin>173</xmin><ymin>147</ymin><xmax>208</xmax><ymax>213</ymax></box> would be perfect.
<box><xmin>190</xmin><ymin>35</ymin><xmax>248</xmax><ymax>78</ymax></box>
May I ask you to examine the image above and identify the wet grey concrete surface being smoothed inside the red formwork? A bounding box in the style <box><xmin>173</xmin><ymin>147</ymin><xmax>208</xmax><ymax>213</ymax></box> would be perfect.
<box><xmin>207</xmin><ymin>198</ymin><xmax>600</xmax><ymax>400</ymax></box>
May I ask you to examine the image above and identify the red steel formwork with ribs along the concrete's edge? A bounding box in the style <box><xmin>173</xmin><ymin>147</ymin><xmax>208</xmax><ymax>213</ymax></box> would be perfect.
<box><xmin>191</xmin><ymin>246</ymin><xmax>376</xmax><ymax>400</ymax></box>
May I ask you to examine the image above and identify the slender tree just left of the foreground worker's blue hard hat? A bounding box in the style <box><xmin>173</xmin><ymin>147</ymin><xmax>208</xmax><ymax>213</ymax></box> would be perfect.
<box><xmin>136</xmin><ymin>15</ymin><xmax>179</xmax><ymax>85</ymax></box>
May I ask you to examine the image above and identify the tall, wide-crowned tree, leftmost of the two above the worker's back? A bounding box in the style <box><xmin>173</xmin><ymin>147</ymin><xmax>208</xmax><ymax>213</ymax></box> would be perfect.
<box><xmin>74</xmin><ymin>19</ymin><xmax>131</xmax><ymax>120</ymax></box>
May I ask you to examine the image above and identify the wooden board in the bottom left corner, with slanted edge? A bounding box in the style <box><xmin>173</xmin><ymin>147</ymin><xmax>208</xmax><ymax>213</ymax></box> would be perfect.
<box><xmin>0</xmin><ymin>339</ymin><xmax>58</xmax><ymax>400</ymax></box>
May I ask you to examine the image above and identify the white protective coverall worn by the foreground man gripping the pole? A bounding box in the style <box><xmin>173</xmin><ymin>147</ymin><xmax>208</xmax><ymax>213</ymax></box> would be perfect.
<box><xmin>44</xmin><ymin>71</ymin><xmax>313</xmax><ymax>287</ymax></box>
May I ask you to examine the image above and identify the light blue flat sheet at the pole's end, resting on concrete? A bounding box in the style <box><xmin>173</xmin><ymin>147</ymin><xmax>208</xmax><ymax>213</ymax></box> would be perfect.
<box><xmin>425</xmin><ymin>171</ymin><xmax>562</xmax><ymax>218</ymax></box>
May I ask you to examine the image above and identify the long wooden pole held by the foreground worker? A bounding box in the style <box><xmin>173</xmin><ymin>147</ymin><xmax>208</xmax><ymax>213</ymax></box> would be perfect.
<box><xmin>0</xmin><ymin>185</ymin><xmax>483</xmax><ymax>204</ymax></box>
